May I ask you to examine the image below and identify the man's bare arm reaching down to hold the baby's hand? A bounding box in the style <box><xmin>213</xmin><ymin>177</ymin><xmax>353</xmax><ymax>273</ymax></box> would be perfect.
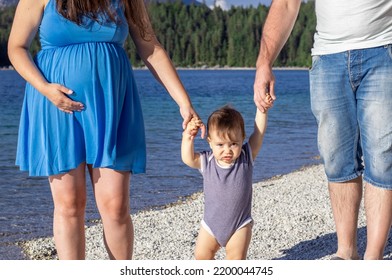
<box><xmin>253</xmin><ymin>0</ymin><xmax>301</xmax><ymax>112</ymax></box>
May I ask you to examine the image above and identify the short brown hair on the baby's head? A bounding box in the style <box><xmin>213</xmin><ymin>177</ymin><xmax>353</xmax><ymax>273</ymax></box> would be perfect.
<box><xmin>207</xmin><ymin>105</ymin><xmax>245</xmax><ymax>139</ymax></box>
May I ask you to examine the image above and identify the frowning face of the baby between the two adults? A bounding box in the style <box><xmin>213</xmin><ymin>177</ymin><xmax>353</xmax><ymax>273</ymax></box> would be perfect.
<box><xmin>208</xmin><ymin>131</ymin><xmax>244</xmax><ymax>166</ymax></box>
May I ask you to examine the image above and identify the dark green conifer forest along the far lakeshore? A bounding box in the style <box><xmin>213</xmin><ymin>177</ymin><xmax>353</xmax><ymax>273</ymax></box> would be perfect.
<box><xmin>0</xmin><ymin>0</ymin><xmax>316</xmax><ymax>67</ymax></box>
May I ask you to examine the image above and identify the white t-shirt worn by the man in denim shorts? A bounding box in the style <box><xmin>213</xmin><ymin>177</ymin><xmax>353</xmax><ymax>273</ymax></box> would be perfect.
<box><xmin>312</xmin><ymin>0</ymin><xmax>392</xmax><ymax>55</ymax></box>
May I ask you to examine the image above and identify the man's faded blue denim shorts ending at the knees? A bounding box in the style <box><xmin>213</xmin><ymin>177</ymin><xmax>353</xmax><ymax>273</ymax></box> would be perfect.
<box><xmin>310</xmin><ymin>45</ymin><xmax>392</xmax><ymax>190</ymax></box>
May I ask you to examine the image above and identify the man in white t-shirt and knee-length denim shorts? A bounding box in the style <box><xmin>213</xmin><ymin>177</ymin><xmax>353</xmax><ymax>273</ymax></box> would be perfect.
<box><xmin>254</xmin><ymin>0</ymin><xmax>392</xmax><ymax>259</ymax></box>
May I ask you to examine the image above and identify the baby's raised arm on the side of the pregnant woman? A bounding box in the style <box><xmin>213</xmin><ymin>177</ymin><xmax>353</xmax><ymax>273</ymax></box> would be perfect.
<box><xmin>181</xmin><ymin>118</ymin><xmax>204</xmax><ymax>169</ymax></box>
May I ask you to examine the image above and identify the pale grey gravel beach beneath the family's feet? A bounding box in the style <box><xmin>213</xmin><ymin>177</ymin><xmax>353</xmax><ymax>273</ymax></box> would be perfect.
<box><xmin>18</xmin><ymin>165</ymin><xmax>392</xmax><ymax>260</ymax></box>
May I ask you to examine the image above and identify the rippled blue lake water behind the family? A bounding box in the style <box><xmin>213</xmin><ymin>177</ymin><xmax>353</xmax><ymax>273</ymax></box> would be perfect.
<box><xmin>0</xmin><ymin>70</ymin><xmax>319</xmax><ymax>260</ymax></box>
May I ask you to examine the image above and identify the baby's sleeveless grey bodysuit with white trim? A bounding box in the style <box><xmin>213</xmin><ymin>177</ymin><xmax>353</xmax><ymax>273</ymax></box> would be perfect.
<box><xmin>200</xmin><ymin>143</ymin><xmax>253</xmax><ymax>247</ymax></box>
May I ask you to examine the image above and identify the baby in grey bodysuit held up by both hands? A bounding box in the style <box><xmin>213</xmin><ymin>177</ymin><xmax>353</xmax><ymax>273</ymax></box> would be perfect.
<box><xmin>181</xmin><ymin>98</ymin><xmax>272</xmax><ymax>260</ymax></box>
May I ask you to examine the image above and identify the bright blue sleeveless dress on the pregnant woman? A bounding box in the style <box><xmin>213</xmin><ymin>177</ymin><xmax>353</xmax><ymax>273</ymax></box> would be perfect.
<box><xmin>16</xmin><ymin>0</ymin><xmax>146</xmax><ymax>176</ymax></box>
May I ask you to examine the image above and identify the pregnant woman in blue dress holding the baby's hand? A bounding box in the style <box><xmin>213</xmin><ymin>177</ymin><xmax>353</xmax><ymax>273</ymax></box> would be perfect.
<box><xmin>8</xmin><ymin>0</ymin><xmax>204</xmax><ymax>259</ymax></box>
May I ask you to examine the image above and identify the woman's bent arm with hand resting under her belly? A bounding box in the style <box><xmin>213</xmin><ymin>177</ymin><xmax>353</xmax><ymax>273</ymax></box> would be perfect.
<box><xmin>8</xmin><ymin>0</ymin><xmax>83</xmax><ymax>113</ymax></box>
